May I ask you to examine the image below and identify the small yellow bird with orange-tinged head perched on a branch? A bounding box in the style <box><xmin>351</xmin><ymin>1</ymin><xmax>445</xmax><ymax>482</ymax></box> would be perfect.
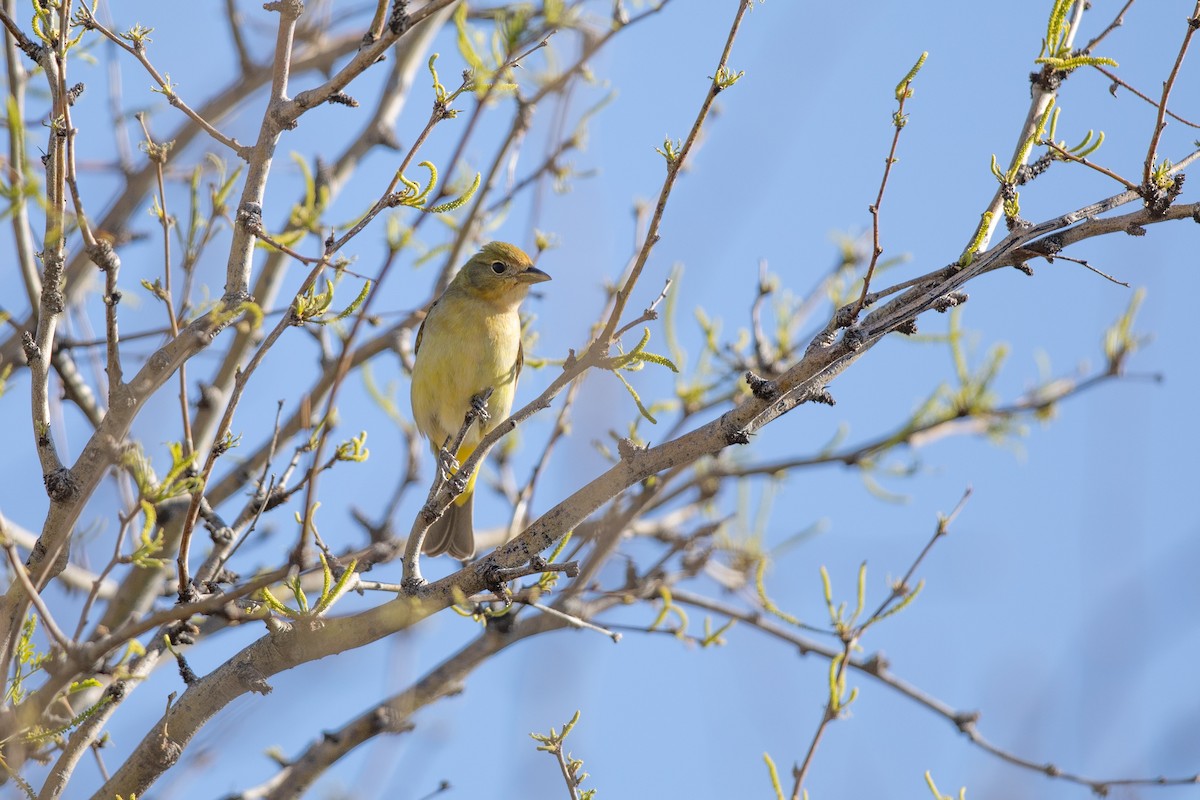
<box><xmin>412</xmin><ymin>241</ymin><xmax>550</xmax><ymax>560</ymax></box>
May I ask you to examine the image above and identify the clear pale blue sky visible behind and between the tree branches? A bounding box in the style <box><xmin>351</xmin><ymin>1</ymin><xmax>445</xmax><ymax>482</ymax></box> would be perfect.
<box><xmin>0</xmin><ymin>0</ymin><xmax>1200</xmax><ymax>799</ymax></box>
